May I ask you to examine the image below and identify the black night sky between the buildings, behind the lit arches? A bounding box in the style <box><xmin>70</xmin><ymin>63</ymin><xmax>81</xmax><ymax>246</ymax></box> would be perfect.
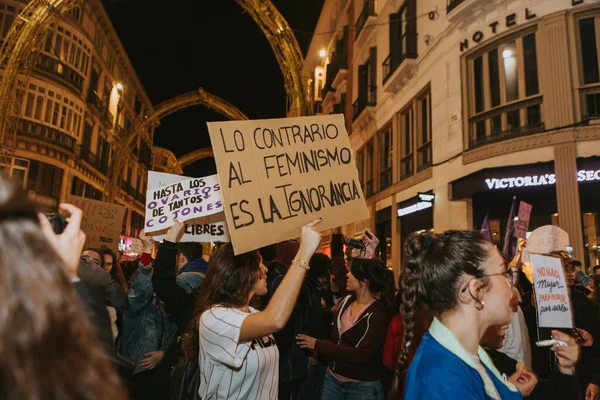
<box><xmin>105</xmin><ymin>0</ymin><xmax>323</xmax><ymax>176</ymax></box>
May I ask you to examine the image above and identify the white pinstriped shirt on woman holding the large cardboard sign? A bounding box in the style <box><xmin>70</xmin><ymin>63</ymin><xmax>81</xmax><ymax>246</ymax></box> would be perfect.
<box><xmin>198</xmin><ymin>307</ymin><xmax>279</xmax><ymax>400</ymax></box>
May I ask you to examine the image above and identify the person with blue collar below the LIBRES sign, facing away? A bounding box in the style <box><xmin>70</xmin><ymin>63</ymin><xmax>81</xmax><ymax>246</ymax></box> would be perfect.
<box><xmin>177</xmin><ymin>242</ymin><xmax>208</xmax><ymax>294</ymax></box>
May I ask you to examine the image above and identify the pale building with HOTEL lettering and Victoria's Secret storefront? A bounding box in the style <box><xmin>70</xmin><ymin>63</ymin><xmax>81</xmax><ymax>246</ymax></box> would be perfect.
<box><xmin>304</xmin><ymin>0</ymin><xmax>600</xmax><ymax>272</ymax></box>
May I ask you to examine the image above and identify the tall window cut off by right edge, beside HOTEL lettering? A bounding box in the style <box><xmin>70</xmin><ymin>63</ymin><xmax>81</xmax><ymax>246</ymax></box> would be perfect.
<box><xmin>577</xmin><ymin>15</ymin><xmax>600</xmax><ymax>120</ymax></box>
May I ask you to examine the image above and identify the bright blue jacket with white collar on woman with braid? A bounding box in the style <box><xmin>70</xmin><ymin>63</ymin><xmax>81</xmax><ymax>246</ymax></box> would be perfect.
<box><xmin>404</xmin><ymin>319</ymin><xmax>522</xmax><ymax>400</ymax></box>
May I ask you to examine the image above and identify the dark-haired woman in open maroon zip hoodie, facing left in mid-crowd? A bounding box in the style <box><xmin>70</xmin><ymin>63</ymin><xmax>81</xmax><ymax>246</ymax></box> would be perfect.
<box><xmin>298</xmin><ymin>258</ymin><xmax>394</xmax><ymax>399</ymax></box>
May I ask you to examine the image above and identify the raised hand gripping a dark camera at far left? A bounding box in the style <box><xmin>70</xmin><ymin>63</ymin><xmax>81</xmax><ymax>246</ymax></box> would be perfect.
<box><xmin>39</xmin><ymin>204</ymin><xmax>86</xmax><ymax>278</ymax></box>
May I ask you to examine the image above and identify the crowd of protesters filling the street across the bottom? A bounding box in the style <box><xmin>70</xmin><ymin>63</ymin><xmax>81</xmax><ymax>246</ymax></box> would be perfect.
<box><xmin>0</xmin><ymin>178</ymin><xmax>600</xmax><ymax>400</ymax></box>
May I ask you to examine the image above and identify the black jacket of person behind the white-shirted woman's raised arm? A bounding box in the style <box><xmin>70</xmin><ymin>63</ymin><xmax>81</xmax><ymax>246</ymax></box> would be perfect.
<box><xmin>266</xmin><ymin>261</ymin><xmax>322</xmax><ymax>383</ymax></box>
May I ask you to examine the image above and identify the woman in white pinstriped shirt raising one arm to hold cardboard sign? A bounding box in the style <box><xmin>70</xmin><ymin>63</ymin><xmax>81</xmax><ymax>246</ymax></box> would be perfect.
<box><xmin>184</xmin><ymin>220</ymin><xmax>321</xmax><ymax>399</ymax></box>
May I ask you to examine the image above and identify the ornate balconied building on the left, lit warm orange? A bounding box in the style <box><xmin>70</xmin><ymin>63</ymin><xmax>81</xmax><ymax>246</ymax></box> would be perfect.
<box><xmin>0</xmin><ymin>0</ymin><xmax>154</xmax><ymax>241</ymax></box>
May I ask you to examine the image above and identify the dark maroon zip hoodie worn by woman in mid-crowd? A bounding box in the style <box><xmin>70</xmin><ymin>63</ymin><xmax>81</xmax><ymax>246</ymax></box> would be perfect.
<box><xmin>315</xmin><ymin>296</ymin><xmax>390</xmax><ymax>381</ymax></box>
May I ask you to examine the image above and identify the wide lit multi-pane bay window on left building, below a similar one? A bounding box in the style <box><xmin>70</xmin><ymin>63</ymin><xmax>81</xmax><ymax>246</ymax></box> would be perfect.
<box><xmin>22</xmin><ymin>83</ymin><xmax>83</xmax><ymax>138</ymax></box>
